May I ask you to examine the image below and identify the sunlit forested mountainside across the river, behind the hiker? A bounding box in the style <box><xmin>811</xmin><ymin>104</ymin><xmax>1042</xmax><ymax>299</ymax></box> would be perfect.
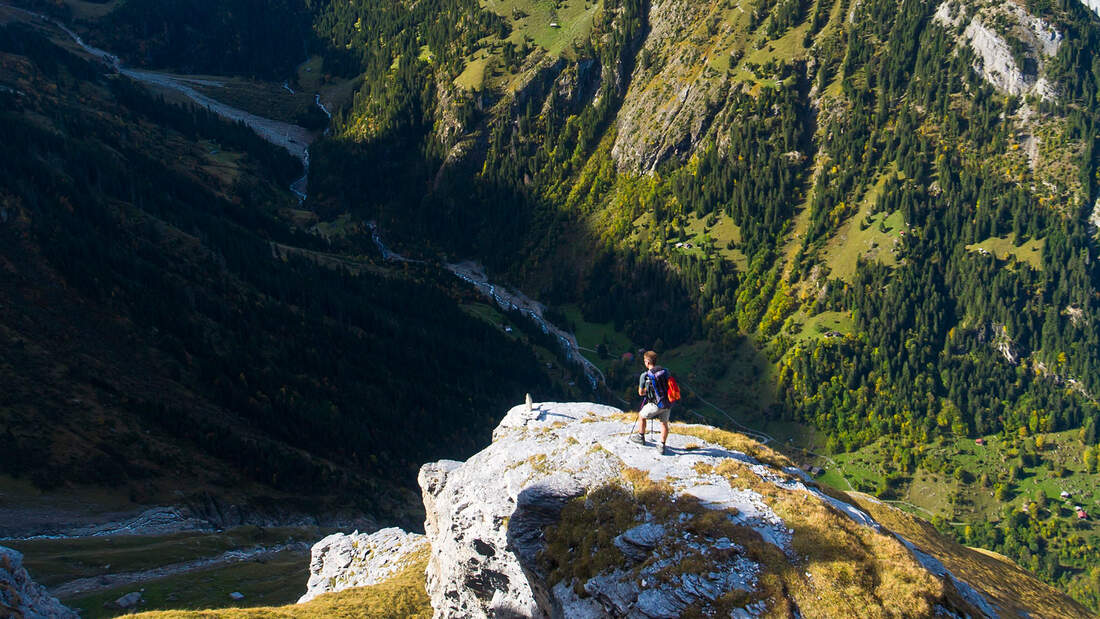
<box><xmin>279</xmin><ymin>0</ymin><xmax>1100</xmax><ymax>605</ymax></box>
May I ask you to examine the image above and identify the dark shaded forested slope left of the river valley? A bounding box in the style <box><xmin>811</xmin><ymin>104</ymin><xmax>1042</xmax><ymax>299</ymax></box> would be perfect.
<box><xmin>0</xmin><ymin>23</ymin><xmax>559</xmax><ymax>521</ymax></box>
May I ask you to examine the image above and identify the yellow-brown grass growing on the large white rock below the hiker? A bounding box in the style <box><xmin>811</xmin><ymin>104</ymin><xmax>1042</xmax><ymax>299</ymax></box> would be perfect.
<box><xmin>540</xmin><ymin>457</ymin><xmax>1007</xmax><ymax>618</ymax></box>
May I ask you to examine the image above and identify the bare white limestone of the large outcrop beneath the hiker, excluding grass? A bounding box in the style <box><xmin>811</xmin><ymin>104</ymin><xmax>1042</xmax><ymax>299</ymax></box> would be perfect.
<box><xmin>420</xmin><ymin>402</ymin><xmax>1003</xmax><ymax>618</ymax></box>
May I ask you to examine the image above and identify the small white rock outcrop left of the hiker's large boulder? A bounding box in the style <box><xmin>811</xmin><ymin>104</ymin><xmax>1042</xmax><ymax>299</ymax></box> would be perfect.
<box><xmin>298</xmin><ymin>528</ymin><xmax>428</xmax><ymax>604</ymax></box>
